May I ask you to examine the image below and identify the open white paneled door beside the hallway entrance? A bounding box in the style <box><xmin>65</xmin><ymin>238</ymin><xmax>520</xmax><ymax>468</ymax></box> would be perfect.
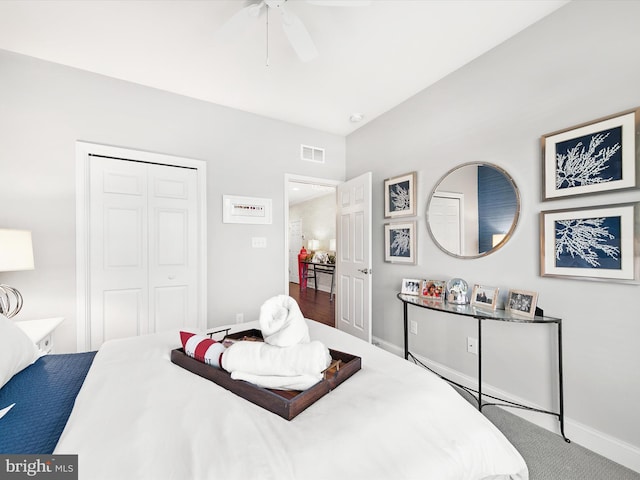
<box><xmin>336</xmin><ymin>172</ymin><xmax>372</xmax><ymax>343</ymax></box>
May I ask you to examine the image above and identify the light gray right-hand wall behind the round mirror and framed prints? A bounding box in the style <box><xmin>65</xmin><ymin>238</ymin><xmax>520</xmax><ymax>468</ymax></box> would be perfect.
<box><xmin>347</xmin><ymin>1</ymin><xmax>640</xmax><ymax>471</ymax></box>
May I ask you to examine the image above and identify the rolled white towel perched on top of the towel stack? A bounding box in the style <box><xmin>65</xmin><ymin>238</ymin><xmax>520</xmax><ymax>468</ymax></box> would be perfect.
<box><xmin>260</xmin><ymin>295</ymin><xmax>310</xmax><ymax>347</ymax></box>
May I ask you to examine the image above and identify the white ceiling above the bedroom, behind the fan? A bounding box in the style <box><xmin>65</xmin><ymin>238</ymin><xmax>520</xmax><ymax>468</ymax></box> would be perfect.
<box><xmin>0</xmin><ymin>0</ymin><xmax>569</xmax><ymax>135</ymax></box>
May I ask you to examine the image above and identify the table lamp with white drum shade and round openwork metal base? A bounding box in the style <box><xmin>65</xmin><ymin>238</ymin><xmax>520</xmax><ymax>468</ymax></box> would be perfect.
<box><xmin>0</xmin><ymin>229</ymin><xmax>34</xmax><ymax>318</ymax></box>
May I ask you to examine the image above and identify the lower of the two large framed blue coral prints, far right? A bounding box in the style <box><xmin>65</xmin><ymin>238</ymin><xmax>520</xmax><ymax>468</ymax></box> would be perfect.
<box><xmin>540</xmin><ymin>203</ymin><xmax>640</xmax><ymax>283</ymax></box>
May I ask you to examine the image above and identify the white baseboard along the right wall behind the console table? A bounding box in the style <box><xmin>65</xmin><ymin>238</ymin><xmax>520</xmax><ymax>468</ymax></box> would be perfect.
<box><xmin>373</xmin><ymin>337</ymin><xmax>640</xmax><ymax>473</ymax></box>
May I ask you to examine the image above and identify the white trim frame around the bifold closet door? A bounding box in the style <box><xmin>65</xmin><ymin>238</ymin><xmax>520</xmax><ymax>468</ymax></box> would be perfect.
<box><xmin>76</xmin><ymin>141</ymin><xmax>207</xmax><ymax>352</ymax></box>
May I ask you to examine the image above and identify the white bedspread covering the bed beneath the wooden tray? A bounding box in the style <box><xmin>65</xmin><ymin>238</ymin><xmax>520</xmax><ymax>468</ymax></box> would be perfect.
<box><xmin>54</xmin><ymin>321</ymin><xmax>528</xmax><ymax>480</ymax></box>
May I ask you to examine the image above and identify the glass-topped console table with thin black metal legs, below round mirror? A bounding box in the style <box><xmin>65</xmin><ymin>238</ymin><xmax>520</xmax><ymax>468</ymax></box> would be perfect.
<box><xmin>398</xmin><ymin>293</ymin><xmax>570</xmax><ymax>443</ymax></box>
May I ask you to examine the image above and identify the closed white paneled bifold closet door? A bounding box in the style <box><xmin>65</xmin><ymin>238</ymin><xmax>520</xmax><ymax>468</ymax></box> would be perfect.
<box><xmin>89</xmin><ymin>156</ymin><xmax>198</xmax><ymax>349</ymax></box>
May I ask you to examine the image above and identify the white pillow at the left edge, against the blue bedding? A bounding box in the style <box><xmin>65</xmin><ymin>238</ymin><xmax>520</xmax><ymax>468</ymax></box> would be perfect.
<box><xmin>0</xmin><ymin>315</ymin><xmax>40</xmax><ymax>388</ymax></box>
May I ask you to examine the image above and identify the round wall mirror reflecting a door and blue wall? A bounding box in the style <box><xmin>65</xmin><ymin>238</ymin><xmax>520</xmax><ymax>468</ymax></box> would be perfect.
<box><xmin>427</xmin><ymin>163</ymin><xmax>520</xmax><ymax>258</ymax></box>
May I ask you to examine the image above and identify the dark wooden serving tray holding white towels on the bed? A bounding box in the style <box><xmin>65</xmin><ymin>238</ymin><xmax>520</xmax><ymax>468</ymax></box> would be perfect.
<box><xmin>171</xmin><ymin>329</ymin><xmax>362</xmax><ymax>420</ymax></box>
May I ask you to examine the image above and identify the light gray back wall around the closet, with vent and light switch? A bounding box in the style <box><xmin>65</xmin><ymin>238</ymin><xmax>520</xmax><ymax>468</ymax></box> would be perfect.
<box><xmin>0</xmin><ymin>51</ymin><xmax>345</xmax><ymax>351</ymax></box>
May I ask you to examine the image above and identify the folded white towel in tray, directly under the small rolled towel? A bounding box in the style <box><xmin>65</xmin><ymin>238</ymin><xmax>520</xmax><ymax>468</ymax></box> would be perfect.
<box><xmin>222</xmin><ymin>341</ymin><xmax>331</xmax><ymax>377</ymax></box>
